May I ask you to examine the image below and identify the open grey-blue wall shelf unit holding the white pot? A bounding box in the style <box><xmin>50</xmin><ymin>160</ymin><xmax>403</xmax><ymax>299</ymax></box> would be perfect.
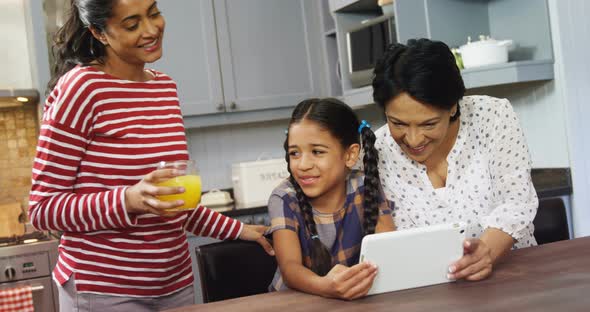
<box><xmin>395</xmin><ymin>0</ymin><xmax>554</xmax><ymax>88</ymax></box>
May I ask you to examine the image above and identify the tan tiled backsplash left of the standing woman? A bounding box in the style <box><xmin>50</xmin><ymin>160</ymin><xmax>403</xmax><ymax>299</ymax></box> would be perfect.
<box><xmin>0</xmin><ymin>104</ymin><xmax>39</xmax><ymax>202</ymax></box>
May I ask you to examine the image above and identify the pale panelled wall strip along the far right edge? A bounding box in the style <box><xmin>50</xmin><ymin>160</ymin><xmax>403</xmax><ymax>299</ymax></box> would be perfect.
<box><xmin>549</xmin><ymin>0</ymin><xmax>590</xmax><ymax>237</ymax></box>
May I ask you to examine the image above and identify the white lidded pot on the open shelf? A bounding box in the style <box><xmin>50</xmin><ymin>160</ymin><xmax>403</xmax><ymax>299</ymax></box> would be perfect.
<box><xmin>459</xmin><ymin>35</ymin><xmax>513</xmax><ymax>68</ymax></box>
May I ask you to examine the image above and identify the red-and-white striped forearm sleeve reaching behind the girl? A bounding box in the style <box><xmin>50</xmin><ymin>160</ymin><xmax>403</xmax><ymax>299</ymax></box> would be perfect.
<box><xmin>184</xmin><ymin>205</ymin><xmax>244</xmax><ymax>240</ymax></box>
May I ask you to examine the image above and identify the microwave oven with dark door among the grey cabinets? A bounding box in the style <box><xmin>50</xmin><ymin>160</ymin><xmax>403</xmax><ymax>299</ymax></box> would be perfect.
<box><xmin>346</xmin><ymin>16</ymin><xmax>397</xmax><ymax>88</ymax></box>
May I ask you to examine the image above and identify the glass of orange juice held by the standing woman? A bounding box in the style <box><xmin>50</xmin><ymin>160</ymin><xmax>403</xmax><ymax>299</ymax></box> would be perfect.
<box><xmin>157</xmin><ymin>160</ymin><xmax>201</xmax><ymax>211</ymax></box>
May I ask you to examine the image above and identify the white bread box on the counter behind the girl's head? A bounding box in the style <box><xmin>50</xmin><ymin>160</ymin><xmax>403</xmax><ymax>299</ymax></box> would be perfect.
<box><xmin>232</xmin><ymin>158</ymin><xmax>289</xmax><ymax>209</ymax></box>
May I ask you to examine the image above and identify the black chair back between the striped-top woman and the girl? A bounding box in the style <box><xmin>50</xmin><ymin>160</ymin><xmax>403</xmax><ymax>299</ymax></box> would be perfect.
<box><xmin>196</xmin><ymin>240</ymin><xmax>277</xmax><ymax>303</ymax></box>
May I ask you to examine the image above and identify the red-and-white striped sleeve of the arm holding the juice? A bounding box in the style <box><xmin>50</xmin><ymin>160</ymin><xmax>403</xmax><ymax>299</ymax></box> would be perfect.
<box><xmin>28</xmin><ymin>119</ymin><xmax>135</xmax><ymax>232</ymax></box>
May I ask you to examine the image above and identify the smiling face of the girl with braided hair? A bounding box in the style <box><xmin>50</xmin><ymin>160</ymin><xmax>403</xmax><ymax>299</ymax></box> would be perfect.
<box><xmin>288</xmin><ymin>119</ymin><xmax>360</xmax><ymax>202</ymax></box>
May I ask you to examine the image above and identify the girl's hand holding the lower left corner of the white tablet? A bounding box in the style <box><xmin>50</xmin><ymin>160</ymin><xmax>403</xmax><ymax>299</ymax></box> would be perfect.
<box><xmin>324</xmin><ymin>262</ymin><xmax>377</xmax><ymax>300</ymax></box>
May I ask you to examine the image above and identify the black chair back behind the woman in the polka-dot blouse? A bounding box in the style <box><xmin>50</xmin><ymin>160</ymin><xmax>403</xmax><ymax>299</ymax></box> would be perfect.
<box><xmin>533</xmin><ymin>197</ymin><xmax>570</xmax><ymax>245</ymax></box>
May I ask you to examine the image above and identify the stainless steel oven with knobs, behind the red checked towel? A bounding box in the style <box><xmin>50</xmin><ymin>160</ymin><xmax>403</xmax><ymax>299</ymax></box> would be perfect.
<box><xmin>0</xmin><ymin>232</ymin><xmax>59</xmax><ymax>312</ymax></box>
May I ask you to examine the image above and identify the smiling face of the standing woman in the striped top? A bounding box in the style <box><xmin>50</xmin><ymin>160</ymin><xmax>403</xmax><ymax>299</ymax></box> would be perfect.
<box><xmin>93</xmin><ymin>0</ymin><xmax>166</xmax><ymax>65</ymax></box>
